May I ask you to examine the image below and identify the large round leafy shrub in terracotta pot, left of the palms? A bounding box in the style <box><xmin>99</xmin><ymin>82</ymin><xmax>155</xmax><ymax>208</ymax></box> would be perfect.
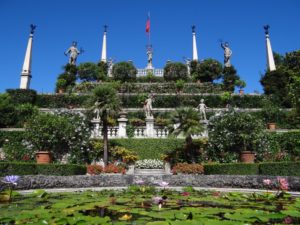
<box><xmin>25</xmin><ymin>113</ymin><xmax>70</xmax><ymax>164</ymax></box>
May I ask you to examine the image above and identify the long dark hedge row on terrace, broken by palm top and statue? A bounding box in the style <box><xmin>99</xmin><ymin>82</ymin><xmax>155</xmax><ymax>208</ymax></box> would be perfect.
<box><xmin>36</xmin><ymin>93</ymin><xmax>263</xmax><ymax>108</ymax></box>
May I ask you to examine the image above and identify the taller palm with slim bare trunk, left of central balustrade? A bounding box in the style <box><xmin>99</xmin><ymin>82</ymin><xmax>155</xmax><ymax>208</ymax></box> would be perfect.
<box><xmin>92</xmin><ymin>84</ymin><xmax>120</xmax><ymax>165</ymax></box>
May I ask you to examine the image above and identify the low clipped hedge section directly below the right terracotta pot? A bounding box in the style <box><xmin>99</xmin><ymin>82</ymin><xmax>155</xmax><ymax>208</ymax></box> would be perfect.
<box><xmin>204</xmin><ymin>163</ymin><xmax>259</xmax><ymax>175</ymax></box>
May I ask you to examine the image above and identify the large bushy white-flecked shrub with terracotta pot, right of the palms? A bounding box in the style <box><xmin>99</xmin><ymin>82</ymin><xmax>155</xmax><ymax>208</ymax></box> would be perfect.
<box><xmin>208</xmin><ymin>111</ymin><xmax>265</xmax><ymax>163</ymax></box>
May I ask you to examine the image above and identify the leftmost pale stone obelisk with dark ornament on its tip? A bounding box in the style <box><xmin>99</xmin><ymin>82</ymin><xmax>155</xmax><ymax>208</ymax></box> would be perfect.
<box><xmin>20</xmin><ymin>24</ymin><xmax>36</xmax><ymax>89</ymax></box>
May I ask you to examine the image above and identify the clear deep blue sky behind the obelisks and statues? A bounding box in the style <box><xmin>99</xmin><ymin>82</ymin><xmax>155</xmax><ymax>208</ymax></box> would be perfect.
<box><xmin>0</xmin><ymin>0</ymin><xmax>300</xmax><ymax>93</ymax></box>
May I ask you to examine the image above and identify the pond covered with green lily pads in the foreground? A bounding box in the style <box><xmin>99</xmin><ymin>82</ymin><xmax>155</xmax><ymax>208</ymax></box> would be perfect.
<box><xmin>0</xmin><ymin>186</ymin><xmax>300</xmax><ymax>225</ymax></box>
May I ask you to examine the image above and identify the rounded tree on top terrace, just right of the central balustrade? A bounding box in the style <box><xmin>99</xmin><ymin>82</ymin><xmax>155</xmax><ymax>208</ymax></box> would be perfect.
<box><xmin>164</xmin><ymin>62</ymin><xmax>188</xmax><ymax>81</ymax></box>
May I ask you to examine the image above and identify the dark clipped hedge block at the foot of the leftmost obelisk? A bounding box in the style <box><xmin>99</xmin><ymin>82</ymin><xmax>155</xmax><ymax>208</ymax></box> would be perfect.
<box><xmin>6</xmin><ymin>89</ymin><xmax>37</xmax><ymax>105</ymax></box>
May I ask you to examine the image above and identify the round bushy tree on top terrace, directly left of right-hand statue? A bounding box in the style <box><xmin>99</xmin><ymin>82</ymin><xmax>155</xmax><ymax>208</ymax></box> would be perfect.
<box><xmin>191</xmin><ymin>59</ymin><xmax>223</xmax><ymax>82</ymax></box>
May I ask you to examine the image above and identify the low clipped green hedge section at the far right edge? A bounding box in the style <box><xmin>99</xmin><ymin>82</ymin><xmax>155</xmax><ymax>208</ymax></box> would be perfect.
<box><xmin>259</xmin><ymin>162</ymin><xmax>300</xmax><ymax>176</ymax></box>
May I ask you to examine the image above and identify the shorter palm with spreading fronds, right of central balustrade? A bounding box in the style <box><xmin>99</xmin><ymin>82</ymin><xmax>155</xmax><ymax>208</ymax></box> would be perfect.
<box><xmin>170</xmin><ymin>108</ymin><xmax>204</xmax><ymax>163</ymax></box>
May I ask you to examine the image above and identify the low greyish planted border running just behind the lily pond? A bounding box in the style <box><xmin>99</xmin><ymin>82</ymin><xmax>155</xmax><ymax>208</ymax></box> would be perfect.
<box><xmin>6</xmin><ymin>174</ymin><xmax>300</xmax><ymax>191</ymax></box>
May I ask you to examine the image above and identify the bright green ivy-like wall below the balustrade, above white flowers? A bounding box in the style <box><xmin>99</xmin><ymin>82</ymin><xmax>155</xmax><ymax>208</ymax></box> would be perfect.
<box><xmin>109</xmin><ymin>138</ymin><xmax>184</xmax><ymax>159</ymax></box>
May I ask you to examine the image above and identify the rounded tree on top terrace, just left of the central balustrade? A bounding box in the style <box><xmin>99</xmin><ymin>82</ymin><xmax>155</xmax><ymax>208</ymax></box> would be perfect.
<box><xmin>112</xmin><ymin>62</ymin><xmax>137</xmax><ymax>82</ymax></box>
